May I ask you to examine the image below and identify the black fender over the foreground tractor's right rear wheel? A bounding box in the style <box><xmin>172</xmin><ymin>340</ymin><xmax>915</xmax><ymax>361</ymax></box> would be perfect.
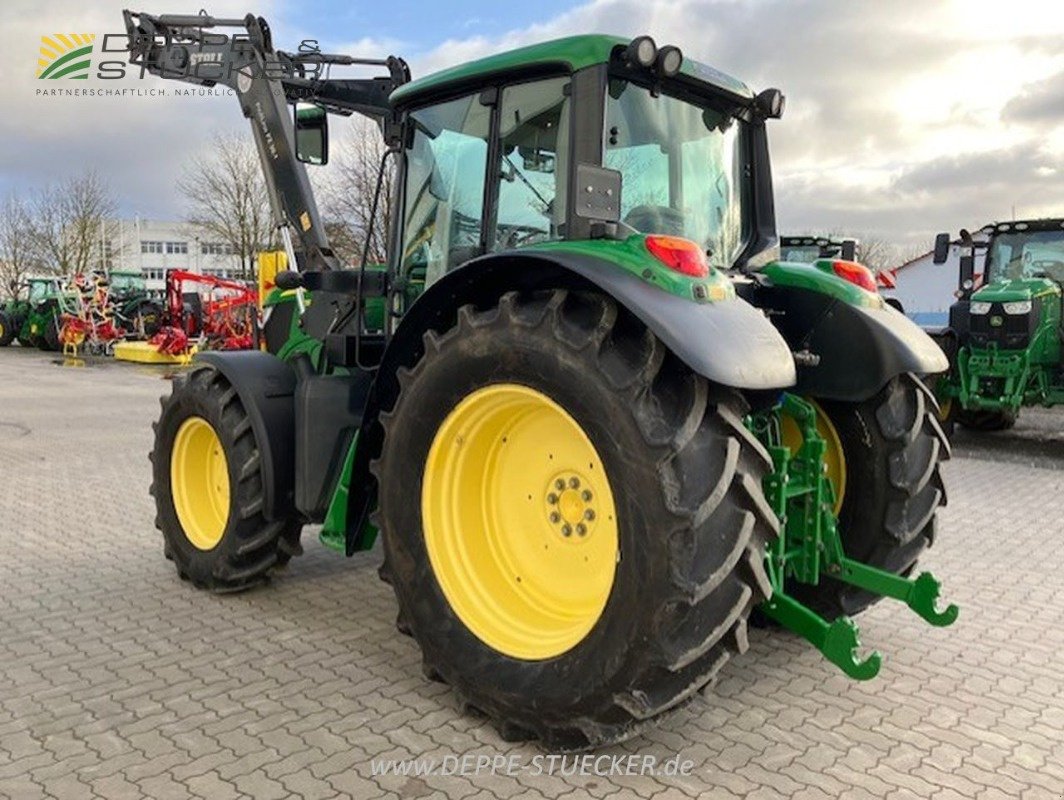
<box><xmin>765</xmin><ymin>286</ymin><xmax>949</xmax><ymax>401</ymax></box>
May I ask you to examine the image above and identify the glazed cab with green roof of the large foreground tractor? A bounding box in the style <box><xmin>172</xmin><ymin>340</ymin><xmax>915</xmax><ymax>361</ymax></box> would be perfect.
<box><xmin>390</xmin><ymin>35</ymin><xmax>782</xmax><ymax>310</ymax></box>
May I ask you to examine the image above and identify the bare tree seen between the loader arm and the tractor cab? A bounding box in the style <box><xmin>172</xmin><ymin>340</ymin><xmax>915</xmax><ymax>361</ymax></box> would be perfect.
<box><xmin>312</xmin><ymin>117</ymin><xmax>396</xmax><ymax>264</ymax></box>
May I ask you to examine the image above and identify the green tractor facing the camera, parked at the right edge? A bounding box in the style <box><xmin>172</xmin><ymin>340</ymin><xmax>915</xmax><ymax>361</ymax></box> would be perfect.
<box><xmin>932</xmin><ymin>219</ymin><xmax>1064</xmax><ymax>431</ymax></box>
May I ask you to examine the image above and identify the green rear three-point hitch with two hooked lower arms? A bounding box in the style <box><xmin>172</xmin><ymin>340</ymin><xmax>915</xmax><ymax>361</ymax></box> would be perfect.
<box><xmin>749</xmin><ymin>394</ymin><xmax>959</xmax><ymax>681</ymax></box>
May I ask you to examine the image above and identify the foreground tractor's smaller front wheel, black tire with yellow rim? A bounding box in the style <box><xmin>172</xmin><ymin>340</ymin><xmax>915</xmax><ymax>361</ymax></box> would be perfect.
<box><xmin>151</xmin><ymin>366</ymin><xmax>302</xmax><ymax>591</ymax></box>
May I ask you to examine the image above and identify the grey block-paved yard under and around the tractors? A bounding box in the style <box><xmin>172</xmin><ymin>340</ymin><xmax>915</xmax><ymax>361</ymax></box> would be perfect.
<box><xmin>0</xmin><ymin>348</ymin><xmax>1064</xmax><ymax>800</ymax></box>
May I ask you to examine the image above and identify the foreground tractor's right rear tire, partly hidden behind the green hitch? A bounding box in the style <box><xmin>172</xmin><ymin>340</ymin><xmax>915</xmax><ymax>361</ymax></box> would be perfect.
<box><xmin>792</xmin><ymin>376</ymin><xmax>950</xmax><ymax>619</ymax></box>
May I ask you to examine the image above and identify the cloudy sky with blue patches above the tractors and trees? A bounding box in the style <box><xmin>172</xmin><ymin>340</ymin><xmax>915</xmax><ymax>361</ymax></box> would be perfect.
<box><xmin>0</xmin><ymin>0</ymin><xmax>1064</xmax><ymax>254</ymax></box>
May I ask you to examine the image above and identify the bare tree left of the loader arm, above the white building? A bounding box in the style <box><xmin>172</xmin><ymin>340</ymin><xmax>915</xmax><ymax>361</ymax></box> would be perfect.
<box><xmin>178</xmin><ymin>133</ymin><xmax>275</xmax><ymax>280</ymax></box>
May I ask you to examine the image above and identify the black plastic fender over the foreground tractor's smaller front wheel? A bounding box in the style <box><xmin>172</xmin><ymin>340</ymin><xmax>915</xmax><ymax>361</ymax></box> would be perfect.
<box><xmin>193</xmin><ymin>350</ymin><xmax>297</xmax><ymax>520</ymax></box>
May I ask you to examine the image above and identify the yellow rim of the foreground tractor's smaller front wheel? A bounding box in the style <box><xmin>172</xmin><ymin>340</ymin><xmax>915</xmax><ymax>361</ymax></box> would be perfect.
<box><xmin>170</xmin><ymin>417</ymin><xmax>229</xmax><ymax>550</ymax></box>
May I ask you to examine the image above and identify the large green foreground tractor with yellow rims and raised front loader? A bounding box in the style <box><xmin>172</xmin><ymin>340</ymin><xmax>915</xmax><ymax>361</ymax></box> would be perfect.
<box><xmin>126</xmin><ymin>12</ymin><xmax>958</xmax><ymax>749</ymax></box>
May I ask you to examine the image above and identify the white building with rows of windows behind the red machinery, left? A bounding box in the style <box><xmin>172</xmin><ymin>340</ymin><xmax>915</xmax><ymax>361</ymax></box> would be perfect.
<box><xmin>103</xmin><ymin>218</ymin><xmax>246</xmax><ymax>290</ymax></box>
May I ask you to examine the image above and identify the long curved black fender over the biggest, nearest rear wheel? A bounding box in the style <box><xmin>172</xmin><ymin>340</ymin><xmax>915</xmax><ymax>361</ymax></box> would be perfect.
<box><xmin>347</xmin><ymin>251</ymin><xmax>796</xmax><ymax>554</ymax></box>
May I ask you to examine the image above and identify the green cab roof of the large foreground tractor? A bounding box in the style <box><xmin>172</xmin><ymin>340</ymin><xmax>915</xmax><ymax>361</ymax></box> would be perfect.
<box><xmin>390</xmin><ymin>34</ymin><xmax>753</xmax><ymax>106</ymax></box>
